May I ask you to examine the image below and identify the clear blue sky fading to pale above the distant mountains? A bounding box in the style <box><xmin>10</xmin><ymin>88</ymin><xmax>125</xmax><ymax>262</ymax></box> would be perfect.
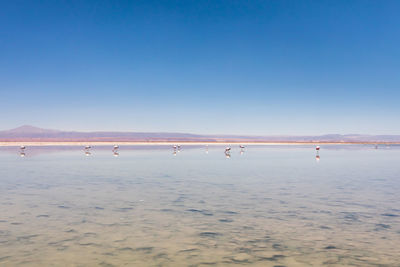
<box><xmin>0</xmin><ymin>0</ymin><xmax>400</xmax><ymax>135</ymax></box>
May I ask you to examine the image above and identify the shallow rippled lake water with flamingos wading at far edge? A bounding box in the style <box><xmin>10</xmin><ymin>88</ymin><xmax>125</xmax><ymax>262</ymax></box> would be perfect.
<box><xmin>0</xmin><ymin>146</ymin><xmax>400</xmax><ymax>266</ymax></box>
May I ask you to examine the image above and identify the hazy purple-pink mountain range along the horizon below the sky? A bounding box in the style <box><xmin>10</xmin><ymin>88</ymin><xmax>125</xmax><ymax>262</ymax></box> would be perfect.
<box><xmin>0</xmin><ymin>125</ymin><xmax>400</xmax><ymax>143</ymax></box>
